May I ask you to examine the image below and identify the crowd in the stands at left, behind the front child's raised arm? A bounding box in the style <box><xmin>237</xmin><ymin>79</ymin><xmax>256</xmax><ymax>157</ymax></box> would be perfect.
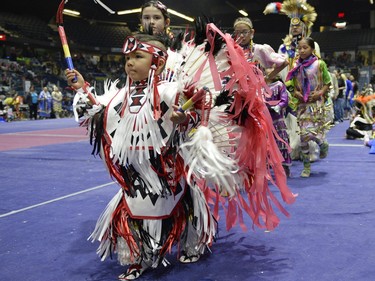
<box><xmin>0</xmin><ymin>46</ymin><xmax>127</xmax><ymax>122</ymax></box>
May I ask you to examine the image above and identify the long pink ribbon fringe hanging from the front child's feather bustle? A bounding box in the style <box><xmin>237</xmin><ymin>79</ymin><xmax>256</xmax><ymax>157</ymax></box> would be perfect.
<box><xmin>207</xmin><ymin>24</ymin><xmax>296</xmax><ymax>230</ymax></box>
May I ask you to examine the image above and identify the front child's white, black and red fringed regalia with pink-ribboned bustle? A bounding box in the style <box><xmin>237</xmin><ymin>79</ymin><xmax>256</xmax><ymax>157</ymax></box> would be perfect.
<box><xmin>72</xmin><ymin>24</ymin><xmax>295</xmax><ymax>274</ymax></box>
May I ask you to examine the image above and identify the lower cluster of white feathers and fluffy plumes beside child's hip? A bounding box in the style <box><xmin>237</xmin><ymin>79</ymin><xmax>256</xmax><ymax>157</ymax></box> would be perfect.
<box><xmin>180</xmin><ymin>107</ymin><xmax>240</xmax><ymax>196</ymax></box>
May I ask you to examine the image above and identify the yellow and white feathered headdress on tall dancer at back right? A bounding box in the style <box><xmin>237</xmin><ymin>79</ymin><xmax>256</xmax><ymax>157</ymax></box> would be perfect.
<box><xmin>263</xmin><ymin>0</ymin><xmax>318</xmax><ymax>36</ymax></box>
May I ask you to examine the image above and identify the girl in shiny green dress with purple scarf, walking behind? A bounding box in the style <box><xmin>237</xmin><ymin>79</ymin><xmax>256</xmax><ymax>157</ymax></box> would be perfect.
<box><xmin>286</xmin><ymin>37</ymin><xmax>331</xmax><ymax>177</ymax></box>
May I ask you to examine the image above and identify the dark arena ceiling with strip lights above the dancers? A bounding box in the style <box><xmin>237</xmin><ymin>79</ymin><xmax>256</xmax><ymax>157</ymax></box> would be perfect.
<box><xmin>1</xmin><ymin>0</ymin><xmax>375</xmax><ymax>33</ymax></box>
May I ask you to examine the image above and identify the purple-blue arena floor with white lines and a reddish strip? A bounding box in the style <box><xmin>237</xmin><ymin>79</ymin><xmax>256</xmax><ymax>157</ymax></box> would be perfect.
<box><xmin>0</xmin><ymin>119</ymin><xmax>375</xmax><ymax>281</ymax></box>
